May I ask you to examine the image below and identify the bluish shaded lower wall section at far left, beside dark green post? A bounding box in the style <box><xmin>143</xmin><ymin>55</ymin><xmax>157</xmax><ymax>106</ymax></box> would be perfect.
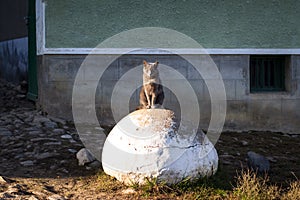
<box><xmin>0</xmin><ymin>37</ymin><xmax>28</xmax><ymax>84</ymax></box>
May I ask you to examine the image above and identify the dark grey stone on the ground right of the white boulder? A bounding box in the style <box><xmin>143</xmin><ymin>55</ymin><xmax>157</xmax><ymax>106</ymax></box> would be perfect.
<box><xmin>247</xmin><ymin>151</ymin><xmax>270</xmax><ymax>173</ymax></box>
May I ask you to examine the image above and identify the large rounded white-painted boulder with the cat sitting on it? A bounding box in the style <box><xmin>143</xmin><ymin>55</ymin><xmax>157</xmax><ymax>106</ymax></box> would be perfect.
<box><xmin>102</xmin><ymin>109</ymin><xmax>218</xmax><ymax>185</ymax></box>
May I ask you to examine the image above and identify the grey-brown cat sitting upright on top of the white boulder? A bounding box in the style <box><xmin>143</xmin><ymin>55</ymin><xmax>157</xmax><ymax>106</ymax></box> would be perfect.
<box><xmin>137</xmin><ymin>60</ymin><xmax>165</xmax><ymax>109</ymax></box>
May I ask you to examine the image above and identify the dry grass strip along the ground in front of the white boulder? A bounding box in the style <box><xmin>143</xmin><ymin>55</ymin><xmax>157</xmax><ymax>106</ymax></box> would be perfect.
<box><xmin>122</xmin><ymin>170</ymin><xmax>300</xmax><ymax>200</ymax></box>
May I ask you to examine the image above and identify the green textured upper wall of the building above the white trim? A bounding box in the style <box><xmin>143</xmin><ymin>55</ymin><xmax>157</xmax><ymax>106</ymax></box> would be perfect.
<box><xmin>45</xmin><ymin>0</ymin><xmax>300</xmax><ymax>48</ymax></box>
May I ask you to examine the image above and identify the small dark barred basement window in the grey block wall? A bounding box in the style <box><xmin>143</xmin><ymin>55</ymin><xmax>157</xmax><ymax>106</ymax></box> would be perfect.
<box><xmin>250</xmin><ymin>55</ymin><xmax>287</xmax><ymax>92</ymax></box>
